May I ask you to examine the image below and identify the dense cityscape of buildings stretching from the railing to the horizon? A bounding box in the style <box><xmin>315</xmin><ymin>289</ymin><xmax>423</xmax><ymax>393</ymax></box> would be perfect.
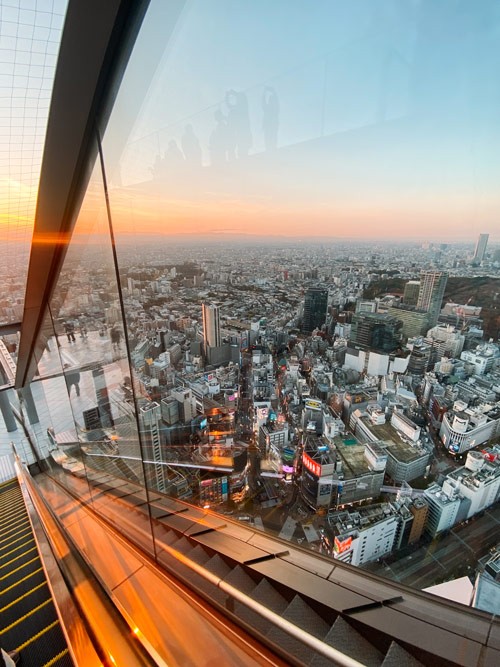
<box><xmin>0</xmin><ymin>234</ymin><xmax>500</xmax><ymax>612</ymax></box>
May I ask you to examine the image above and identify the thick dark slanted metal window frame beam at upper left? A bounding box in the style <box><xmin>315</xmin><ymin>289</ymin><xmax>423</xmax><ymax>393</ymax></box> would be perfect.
<box><xmin>15</xmin><ymin>0</ymin><xmax>149</xmax><ymax>388</ymax></box>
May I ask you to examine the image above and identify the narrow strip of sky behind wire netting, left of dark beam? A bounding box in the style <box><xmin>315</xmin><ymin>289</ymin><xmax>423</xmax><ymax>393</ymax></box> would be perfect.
<box><xmin>0</xmin><ymin>0</ymin><xmax>67</xmax><ymax>252</ymax></box>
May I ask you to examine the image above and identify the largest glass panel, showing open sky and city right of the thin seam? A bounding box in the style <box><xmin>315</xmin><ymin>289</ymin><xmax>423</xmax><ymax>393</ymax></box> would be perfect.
<box><xmin>94</xmin><ymin>0</ymin><xmax>500</xmax><ymax>600</ymax></box>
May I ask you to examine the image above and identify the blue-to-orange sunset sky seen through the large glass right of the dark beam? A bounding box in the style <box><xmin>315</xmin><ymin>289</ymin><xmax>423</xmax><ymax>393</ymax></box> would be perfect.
<box><xmin>0</xmin><ymin>0</ymin><xmax>500</xmax><ymax>247</ymax></box>
